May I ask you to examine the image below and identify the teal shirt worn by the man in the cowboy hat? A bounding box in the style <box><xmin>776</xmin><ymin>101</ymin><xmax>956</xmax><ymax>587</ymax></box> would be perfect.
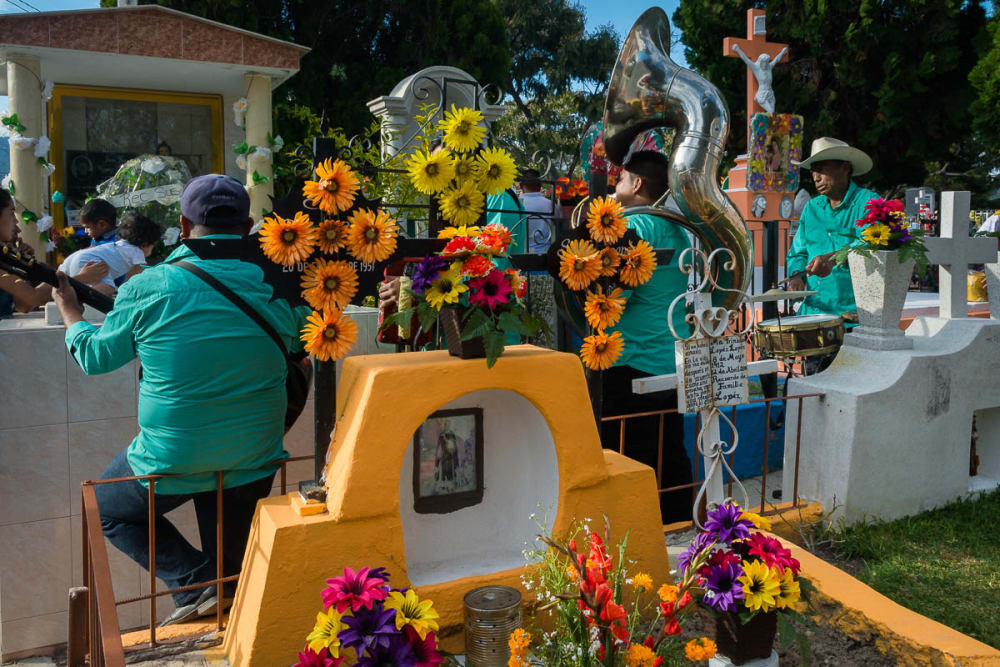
<box><xmin>786</xmin><ymin>181</ymin><xmax>878</xmax><ymax>315</ymax></box>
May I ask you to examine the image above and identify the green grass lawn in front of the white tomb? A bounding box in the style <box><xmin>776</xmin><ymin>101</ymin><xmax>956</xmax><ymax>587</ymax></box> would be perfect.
<box><xmin>826</xmin><ymin>491</ymin><xmax>1000</xmax><ymax>648</ymax></box>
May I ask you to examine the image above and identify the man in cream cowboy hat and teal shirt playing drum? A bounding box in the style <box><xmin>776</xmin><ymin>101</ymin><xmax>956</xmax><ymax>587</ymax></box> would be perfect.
<box><xmin>786</xmin><ymin>137</ymin><xmax>878</xmax><ymax>315</ymax></box>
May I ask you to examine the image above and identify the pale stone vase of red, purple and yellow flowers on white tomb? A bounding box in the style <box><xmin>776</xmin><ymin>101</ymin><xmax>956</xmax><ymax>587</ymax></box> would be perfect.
<box><xmin>835</xmin><ymin>199</ymin><xmax>927</xmax><ymax>336</ymax></box>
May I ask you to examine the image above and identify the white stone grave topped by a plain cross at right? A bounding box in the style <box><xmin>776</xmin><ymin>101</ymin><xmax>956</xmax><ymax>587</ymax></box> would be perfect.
<box><xmin>783</xmin><ymin>192</ymin><xmax>1000</xmax><ymax>523</ymax></box>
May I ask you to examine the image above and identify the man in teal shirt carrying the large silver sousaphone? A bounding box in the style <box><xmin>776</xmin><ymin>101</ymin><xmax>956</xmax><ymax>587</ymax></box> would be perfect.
<box><xmin>601</xmin><ymin>151</ymin><xmax>691</xmax><ymax>523</ymax></box>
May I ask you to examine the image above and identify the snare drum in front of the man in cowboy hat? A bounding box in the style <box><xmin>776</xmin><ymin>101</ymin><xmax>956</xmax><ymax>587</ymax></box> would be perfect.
<box><xmin>753</xmin><ymin>315</ymin><xmax>844</xmax><ymax>357</ymax></box>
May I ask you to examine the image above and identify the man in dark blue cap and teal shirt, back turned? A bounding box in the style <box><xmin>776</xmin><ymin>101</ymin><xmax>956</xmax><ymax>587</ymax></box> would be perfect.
<box><xmin>54</xmin><ymin>174</ymin><xmax>307</xmax><ymax>625</ymax></box>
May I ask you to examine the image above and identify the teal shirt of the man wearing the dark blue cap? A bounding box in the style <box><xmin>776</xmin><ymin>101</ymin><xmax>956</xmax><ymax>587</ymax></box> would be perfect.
<box><xmin>66</xmin><ymin>235</ymin><xmax>309</xmax><ymax>494</ymax></box>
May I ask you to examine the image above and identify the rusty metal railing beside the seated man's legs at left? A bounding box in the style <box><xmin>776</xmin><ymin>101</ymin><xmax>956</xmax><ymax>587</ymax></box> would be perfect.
<box><xmin>75</xmin><ymin>456</ymin><xmax>313</xmax><ymax>667</ymax></box>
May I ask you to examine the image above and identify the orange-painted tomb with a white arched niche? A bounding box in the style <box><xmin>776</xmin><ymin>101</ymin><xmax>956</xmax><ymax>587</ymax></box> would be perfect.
<box><xmin>225</xmin><ymin>345</ymin><xmax>670</xmax><ymax>667</ymax></box>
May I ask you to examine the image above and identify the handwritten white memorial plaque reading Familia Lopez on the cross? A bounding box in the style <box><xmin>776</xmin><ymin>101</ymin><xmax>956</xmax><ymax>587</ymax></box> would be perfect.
<box><xmin>674</xmin><ymin>336</ymin><xmax>749</xmax><ymax>412</ymax></box>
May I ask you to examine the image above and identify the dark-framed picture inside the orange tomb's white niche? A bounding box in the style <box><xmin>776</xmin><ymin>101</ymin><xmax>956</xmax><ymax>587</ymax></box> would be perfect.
<box><xmin>413</xmin><ymin>408</ymin><xmax>483</xmax><ymax>514</ymax></box>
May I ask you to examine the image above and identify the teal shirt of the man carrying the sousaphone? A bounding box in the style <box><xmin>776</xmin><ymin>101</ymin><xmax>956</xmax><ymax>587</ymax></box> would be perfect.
<box><xmin>608</xmin><ymin>213</ymin><xmax>690</xmax><ymax>375</ymax></box>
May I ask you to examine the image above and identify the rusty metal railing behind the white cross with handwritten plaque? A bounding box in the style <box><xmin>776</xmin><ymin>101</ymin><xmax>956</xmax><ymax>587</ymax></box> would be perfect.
<box><xmin>601</xmin><ymin>393</ymin><xmax>825</xmax><ymax>514</ymax></box>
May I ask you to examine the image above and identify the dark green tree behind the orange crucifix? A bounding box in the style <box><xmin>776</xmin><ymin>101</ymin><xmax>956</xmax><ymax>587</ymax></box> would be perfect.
<box><xmin>673</xmin><ymin>0</ymin><xmax>986</xmax><ymax>190</ymax></box>
